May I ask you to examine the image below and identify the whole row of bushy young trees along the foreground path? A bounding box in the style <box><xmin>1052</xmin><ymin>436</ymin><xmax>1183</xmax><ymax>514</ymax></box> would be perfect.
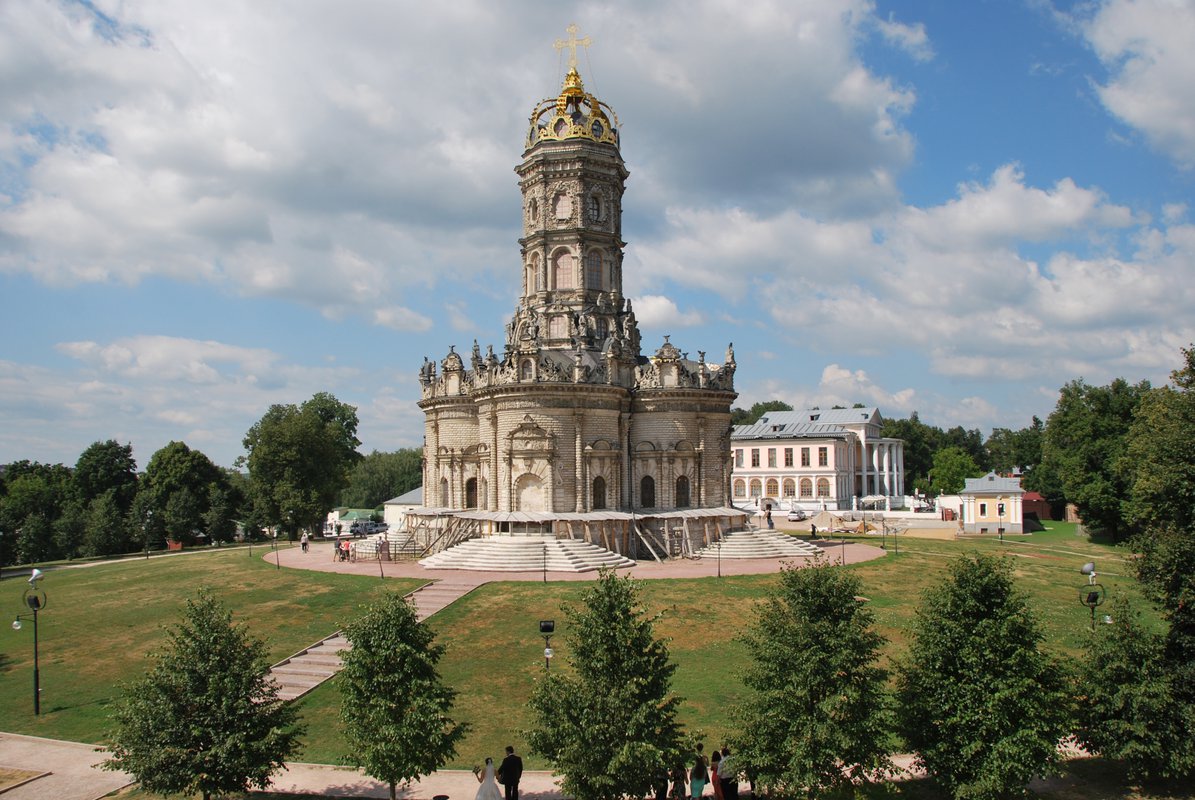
<box><xmin>106</xmin><ymin>526</ymin><xmax>1195</xmax><ymax>800</ymax></box>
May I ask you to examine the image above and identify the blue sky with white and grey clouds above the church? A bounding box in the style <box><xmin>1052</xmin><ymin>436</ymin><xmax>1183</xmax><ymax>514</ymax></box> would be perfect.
<box><xmin>0</xmin><ymin>0</ymin><xmax>1195</xmax><ymax>469</ymax></box>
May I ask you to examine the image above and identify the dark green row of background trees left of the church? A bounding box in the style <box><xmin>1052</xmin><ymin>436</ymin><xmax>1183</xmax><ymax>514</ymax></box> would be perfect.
<box><xmin>0</xmin><ymin>392</ymin><xmax>422</xmax><ymax>566</ymax></box>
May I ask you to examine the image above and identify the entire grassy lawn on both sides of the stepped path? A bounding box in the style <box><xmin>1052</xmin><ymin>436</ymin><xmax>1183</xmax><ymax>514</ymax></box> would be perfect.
<box><xmin>7</xmin><ymin>523</ymin><xmax>1190</xmax><ymax>800</ymax></box>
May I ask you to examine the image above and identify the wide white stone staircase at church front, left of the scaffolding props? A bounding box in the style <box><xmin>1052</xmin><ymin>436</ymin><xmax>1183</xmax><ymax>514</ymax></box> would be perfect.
<box><xmin>419</xmin><ymin>536</ymin><xmax>635</xmax><ymax>573</ymax></box>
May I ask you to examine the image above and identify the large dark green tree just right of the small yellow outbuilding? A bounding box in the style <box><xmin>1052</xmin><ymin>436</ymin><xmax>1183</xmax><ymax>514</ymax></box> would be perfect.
<box><xmin>1042</xmin><ymin>378</ymin><xmax>1150</xmax><ymax>541</ymax></box>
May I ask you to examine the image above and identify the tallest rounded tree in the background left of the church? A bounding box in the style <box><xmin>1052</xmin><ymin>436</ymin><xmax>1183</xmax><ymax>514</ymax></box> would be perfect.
<box><xmin>245</xmin><ymin>392</ymin><xmax>361</xmax><ymax>537</ymax></box>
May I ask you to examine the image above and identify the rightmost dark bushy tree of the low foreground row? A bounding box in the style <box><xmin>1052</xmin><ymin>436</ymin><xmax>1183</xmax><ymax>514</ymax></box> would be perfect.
<box><xmin>1076</xmin><ymin>601</ymin><xmax>1195</xmax><ymax>781</ymax></box>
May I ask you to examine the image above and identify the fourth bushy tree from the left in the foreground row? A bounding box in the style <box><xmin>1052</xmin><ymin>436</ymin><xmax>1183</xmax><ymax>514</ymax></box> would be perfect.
<box><xmin>736</xmin><ymin>560</ymin><xmax>891</xmax><ymax>798</ymax></box>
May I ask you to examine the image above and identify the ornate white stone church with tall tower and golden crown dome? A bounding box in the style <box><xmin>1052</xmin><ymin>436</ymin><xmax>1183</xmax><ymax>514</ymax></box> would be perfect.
<box><xmin>403</xmin><ymin>41</ymin><xmax>743</xmax><ymax>556</ymax></box>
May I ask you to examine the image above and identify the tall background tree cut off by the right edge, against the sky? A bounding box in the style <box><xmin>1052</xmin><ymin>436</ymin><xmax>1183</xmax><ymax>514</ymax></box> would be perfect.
<box><xmin>1120</xmin><ymin>347</ymin><xmax>1195</xmax><ymax>529</ymax></box>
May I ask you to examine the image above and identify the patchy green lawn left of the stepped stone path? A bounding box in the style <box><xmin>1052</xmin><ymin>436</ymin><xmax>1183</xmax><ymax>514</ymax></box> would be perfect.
<box><xmin>0</xmin><ymin>548</ymin><xmax>421</xmax><ymax>743</ymax></box>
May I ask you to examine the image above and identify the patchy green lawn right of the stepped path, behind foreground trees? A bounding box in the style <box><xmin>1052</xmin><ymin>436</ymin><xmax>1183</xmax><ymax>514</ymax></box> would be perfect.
<box><xmin>291</xmin><ymin>524</ymin><xmax>1156</xmax><ymax>769</ymax></box>
